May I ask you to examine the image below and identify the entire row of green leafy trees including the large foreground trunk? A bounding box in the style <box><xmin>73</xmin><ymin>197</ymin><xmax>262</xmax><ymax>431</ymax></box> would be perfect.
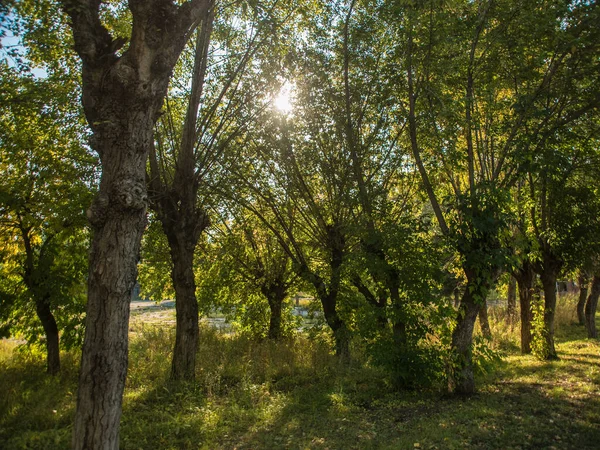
<box><xmin>0</xmin><ymin>0</ymin><xmax>600</xmax><ymax>448</ymax></box>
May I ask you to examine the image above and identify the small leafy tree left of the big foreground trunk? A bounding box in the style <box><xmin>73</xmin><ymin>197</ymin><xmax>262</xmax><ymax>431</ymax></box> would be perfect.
<box><xmin>0</xmin><ymin>62</ymin><xmax>95</xmax><ymax>374</ymax></box>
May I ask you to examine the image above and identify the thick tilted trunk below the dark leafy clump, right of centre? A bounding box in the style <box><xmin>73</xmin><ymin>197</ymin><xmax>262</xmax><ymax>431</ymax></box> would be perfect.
<box><xmin>448</xmin><ymin>281</ymin><xmax>481</xmax><ymax>395</ymax></box>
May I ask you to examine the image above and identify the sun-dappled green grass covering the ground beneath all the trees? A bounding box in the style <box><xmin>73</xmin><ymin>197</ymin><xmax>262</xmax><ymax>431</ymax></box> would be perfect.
<box><xmin>0</xmin><ymin>301</ymin><xmax>600</xmax><ymax>450</ymax></box>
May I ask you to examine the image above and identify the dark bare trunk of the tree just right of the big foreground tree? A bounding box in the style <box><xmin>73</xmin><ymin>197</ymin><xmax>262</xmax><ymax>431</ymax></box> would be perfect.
<box><xmin>163</xmin><ymin>230</ymin><xmax>200</xmax><ymax>381</ymax></box>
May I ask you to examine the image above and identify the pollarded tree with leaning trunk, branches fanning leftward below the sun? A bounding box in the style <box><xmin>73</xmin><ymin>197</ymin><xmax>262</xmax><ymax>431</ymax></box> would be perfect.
<box><xmin>231</xmin><ymin>106</ymin><xmax>352</xmax><ymax>359</ymax></box>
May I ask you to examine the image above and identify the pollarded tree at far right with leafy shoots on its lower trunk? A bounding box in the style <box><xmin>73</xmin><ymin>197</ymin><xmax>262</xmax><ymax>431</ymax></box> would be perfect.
<box><xmin>528</xmin><ymin>133</ymin><xmax>600</xmax><ymax>359</ymax></box>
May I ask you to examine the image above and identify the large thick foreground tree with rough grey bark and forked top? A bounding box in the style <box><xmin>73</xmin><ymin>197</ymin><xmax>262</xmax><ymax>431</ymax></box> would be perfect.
<box><xmin>60</xmin><ymin>0</ymin><xmax>211</xmax><ymax>449</ymax></box>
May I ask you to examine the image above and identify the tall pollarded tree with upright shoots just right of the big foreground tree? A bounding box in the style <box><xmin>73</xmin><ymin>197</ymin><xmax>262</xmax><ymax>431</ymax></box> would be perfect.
<box><xmin>148</xmin><ymin>1</ymin><xmax>298</xmax><ymax>379</ymax></box>
